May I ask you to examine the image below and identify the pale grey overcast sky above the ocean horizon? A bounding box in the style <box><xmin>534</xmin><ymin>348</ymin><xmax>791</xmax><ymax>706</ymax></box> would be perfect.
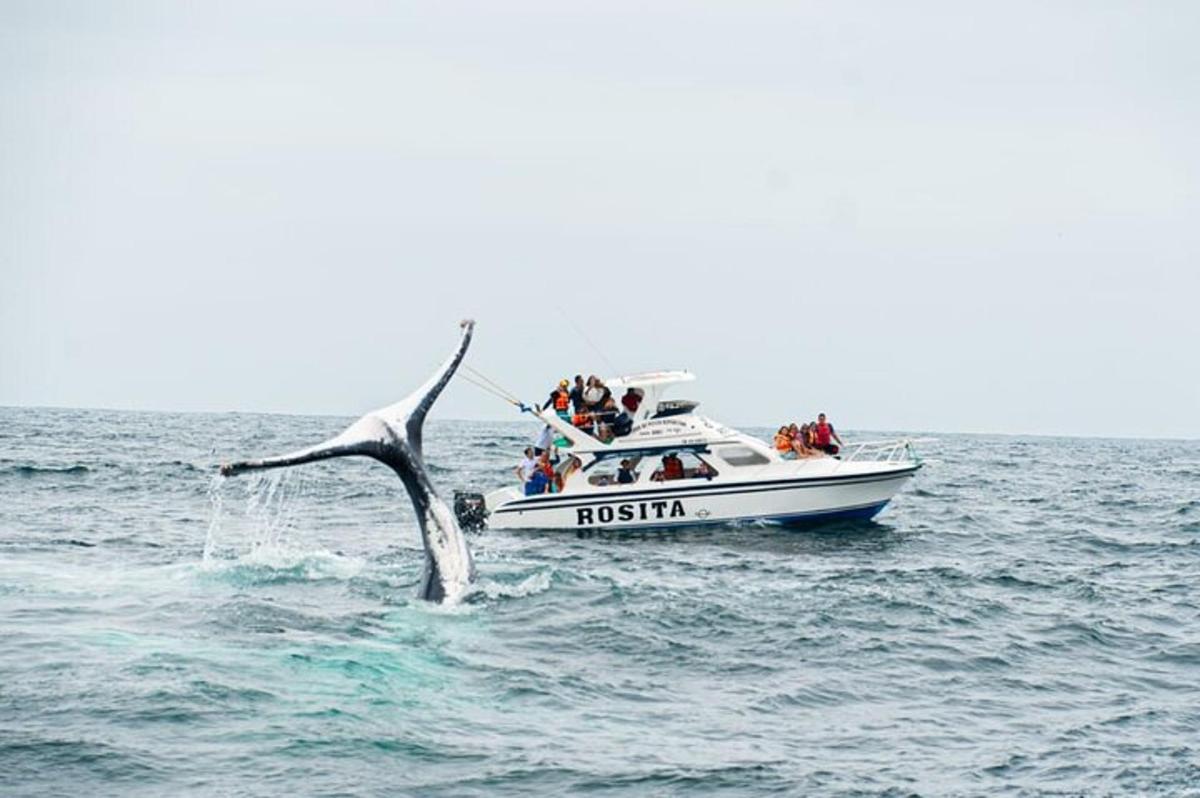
<box><xmin>0</xmin><ymin>0</ymin><xmax>1200</xmax><ymax>437</ymax></box>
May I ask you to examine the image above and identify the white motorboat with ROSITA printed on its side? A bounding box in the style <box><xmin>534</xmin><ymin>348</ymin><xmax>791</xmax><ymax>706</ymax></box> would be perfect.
<box><xmin>455</xmin><ymin>371</ymin><xmax>922</xmax><ymax>529</ymax></box>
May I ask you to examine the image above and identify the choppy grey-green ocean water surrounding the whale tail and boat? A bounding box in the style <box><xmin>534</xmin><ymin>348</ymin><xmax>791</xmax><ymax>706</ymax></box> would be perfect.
<box><xmin>0</xmin><ymin>408</ymin><xmax>1200</xmax><ymax>796</ymax></box>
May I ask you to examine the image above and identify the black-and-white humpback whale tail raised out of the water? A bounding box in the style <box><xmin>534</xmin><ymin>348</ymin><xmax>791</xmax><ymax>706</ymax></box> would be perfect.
<box><xmin>221</xmin><ymin>320</ymin><xmax>475</xmax><ymax>602</ymax></box>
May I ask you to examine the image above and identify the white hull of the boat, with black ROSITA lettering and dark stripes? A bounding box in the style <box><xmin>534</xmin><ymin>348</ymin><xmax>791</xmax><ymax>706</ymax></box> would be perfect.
<box><xmin>487</xmin><ymin>464</ymin><xmax>919</xmax><ymax>529</ymax></box>
